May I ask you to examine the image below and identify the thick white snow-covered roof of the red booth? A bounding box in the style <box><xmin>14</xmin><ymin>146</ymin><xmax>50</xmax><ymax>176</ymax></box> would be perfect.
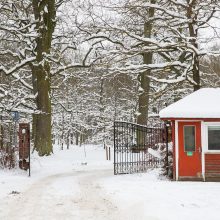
<box><xmin>159</xmin><ymin>88</ymin><xmax>220</xmax><ymax>118</ymax></box>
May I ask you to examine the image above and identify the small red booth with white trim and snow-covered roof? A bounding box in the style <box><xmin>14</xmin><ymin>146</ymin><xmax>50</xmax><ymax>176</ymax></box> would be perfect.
<box><xmin>160</xmin><ymin>88</ymin><xmax>220</xmax><ymax>181</ymax></box>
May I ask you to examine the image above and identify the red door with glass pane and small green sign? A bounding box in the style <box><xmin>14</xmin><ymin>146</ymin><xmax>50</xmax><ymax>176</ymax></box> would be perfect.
<box><xmin>178</xmin><ymin>122</ymin><xmax>202</xmax><ymax>178</ymax></box>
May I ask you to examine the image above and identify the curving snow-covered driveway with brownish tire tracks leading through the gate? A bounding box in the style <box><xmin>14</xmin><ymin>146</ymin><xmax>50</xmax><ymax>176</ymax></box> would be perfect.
<box><xmin>4</xmin><ymin>170</ymin><xmax>117</xmax><ymax>220</ymax></box>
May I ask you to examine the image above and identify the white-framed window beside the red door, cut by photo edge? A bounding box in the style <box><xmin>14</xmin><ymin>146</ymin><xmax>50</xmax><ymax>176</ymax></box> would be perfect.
<box><xmin>208</xmin><ymin>126</ymin><xmax>220</xmax><ymax>150</ymax></box>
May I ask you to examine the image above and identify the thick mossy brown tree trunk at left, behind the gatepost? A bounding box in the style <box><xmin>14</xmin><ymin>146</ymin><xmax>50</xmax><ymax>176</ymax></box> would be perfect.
<box><xmin>32</xmin><ymin>0</ymin><xmax>56</xmax><ymax>156</ymax></box>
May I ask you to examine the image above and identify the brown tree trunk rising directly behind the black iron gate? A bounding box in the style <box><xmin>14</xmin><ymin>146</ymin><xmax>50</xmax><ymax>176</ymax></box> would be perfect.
<box><xmin>137</xmin><ymin>0</ymin><xmax>155</xmax><ymax>125</ymax></box>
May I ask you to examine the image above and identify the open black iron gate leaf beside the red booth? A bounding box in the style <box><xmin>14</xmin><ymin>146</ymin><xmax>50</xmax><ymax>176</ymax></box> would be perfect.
<box><xmin>114</xmin><ymin>121</ymin><xmax>167</xmax><ymax>175</ymax></box>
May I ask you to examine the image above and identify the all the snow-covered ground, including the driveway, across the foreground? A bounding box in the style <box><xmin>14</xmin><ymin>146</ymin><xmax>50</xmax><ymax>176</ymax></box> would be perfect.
<box><xmin>0</xmin><ymin>145</ymin><xmax>220</xmax><ymax>220</ymax></box>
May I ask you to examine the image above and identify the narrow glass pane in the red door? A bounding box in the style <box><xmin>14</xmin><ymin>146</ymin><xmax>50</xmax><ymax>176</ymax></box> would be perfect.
<box><xmin>184</xmin><ymin>126</ymin><xmax>195</xmax><ymax>152</ymax></box>
